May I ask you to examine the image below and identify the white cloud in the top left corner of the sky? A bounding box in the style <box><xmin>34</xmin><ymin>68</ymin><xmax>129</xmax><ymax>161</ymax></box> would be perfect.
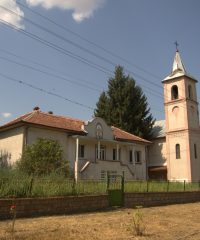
<box><xmin>0</xmin><ymin>0</ymin><xmax>24</xmax><ymax>29</ymax></box>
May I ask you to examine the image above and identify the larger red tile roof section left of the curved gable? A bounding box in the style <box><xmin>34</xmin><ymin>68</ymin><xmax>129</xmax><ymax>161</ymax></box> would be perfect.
<box><xmin>0</xmin><ymin>110</ymin><xmax>85</xmax><ymax>134</ymax></box>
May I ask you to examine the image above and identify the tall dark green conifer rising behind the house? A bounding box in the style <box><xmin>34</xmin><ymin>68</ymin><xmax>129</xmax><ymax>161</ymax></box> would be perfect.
<box><xmin>94</xmin><ymin>66</ymin><xmax>155</xmax><ymax>139</ymax></box>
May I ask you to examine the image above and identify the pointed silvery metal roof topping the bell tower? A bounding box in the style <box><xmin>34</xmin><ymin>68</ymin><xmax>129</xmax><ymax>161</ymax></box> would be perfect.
<box><xmin>162</xmin><ymin>49</ymin><xmax>197</xmax><ymax>82</ymax></box>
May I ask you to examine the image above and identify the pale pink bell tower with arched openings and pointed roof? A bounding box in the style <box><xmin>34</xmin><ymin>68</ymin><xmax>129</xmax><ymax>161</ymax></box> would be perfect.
<box><xmin>162</xmin><ymin>49</ymin><xmax>200</xmax><ymax>181</ymax></box>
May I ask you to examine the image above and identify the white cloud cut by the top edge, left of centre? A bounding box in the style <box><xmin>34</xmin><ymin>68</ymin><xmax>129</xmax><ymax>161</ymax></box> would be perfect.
<box><xmin>26</xmin><ymin>0</ymin><xmax>105</xmax><ymax>22</ymax></box>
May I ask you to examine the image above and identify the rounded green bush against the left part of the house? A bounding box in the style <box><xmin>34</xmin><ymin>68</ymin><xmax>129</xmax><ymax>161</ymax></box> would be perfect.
<box><xmin>17</xmin><ymin>139</ymin><xmax>68</xmax><ymax>175</ymax></box>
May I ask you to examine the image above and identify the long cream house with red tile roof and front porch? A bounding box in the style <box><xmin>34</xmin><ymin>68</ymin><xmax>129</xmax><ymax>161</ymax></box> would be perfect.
<box><xmin>0</xmin><ymin>109</ymin><xmax>150</xmax><ymax>179</ymax></box>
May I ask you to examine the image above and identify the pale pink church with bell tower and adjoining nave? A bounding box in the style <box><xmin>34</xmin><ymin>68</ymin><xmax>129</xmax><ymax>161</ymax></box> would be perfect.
<box><xmin>148</xmin><ymin>50</ymin><xmax>200</xmax><ymax>181</ymax></box>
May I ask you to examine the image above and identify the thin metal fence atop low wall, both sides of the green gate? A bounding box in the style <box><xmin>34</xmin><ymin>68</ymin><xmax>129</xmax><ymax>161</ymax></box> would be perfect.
<box><xmin>0</xmin><ymin>177</ymin><xmax>200</xmax><ymax>198</ymax></box>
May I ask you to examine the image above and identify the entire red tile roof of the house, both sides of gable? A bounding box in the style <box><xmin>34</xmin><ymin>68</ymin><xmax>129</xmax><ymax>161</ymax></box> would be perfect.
<box><xmin>0</xmin><ymin>110</ymin><xmax>150</xmax><ymax>144</ymax></box>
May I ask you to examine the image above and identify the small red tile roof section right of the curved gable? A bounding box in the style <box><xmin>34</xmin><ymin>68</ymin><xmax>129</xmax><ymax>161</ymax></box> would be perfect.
<box><xmin>111</xmin><ymin>126</ymin><xmax>151</xmax><ymax>143</ymax></box>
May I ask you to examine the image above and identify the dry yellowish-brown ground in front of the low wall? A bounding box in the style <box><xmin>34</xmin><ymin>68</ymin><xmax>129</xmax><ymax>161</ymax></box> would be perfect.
<box><xmin>0</xmin><ymin>203</ymin><xmax>200</xmax><ymax>240</ymax></box>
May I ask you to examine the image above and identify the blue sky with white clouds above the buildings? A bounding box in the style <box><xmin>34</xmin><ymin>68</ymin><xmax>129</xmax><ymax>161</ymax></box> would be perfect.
<box><xmin>0</xmin><ymin>0</ymin><xmax>200</xmax><ymax>125</ymax></box>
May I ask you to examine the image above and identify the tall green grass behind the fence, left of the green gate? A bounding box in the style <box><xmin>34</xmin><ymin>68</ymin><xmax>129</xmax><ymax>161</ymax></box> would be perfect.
<box><xmin>0</xmin><ymin>170</ymin><xmax>107</xmax><ymax>198</ymax></box>
